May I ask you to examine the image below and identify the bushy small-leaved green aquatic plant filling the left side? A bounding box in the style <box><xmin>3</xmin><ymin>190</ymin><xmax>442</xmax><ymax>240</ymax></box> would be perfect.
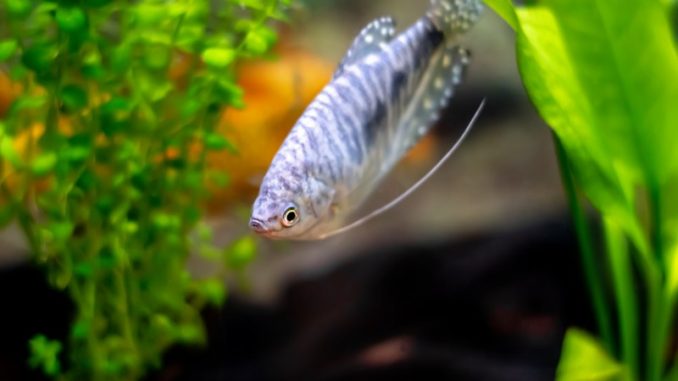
<box><xmin>0</xmin><ymin>0</ymin><xmax>289</xmax><ymax>380</ymax></box>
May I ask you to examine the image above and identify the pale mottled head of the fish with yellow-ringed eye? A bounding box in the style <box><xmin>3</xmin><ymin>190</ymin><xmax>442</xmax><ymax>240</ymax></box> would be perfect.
<box><xmin>249</xmin><ymin>171</ymin><xmax>332</xmax><ymax>240</ymax></box>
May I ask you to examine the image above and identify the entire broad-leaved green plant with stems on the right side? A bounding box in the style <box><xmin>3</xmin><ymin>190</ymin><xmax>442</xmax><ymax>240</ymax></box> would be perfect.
<box><xmin>486</xmin><ymin>0</ymin><xmax>678</xmax><ymax>381</ymax></box>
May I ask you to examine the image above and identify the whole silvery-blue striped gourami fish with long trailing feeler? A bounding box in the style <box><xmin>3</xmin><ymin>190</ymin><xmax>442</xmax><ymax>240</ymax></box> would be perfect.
<box><xmin>250</xmin><ymin>0</ymin><xmax>482</xmax><ymax>240</ymax></box>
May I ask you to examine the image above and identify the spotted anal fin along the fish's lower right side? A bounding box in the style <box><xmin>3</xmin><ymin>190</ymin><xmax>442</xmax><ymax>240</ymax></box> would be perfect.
<box><xmin>394</xmin><ymin>44</ymin><xmax>470</xmax><ymax>157</ymax></box>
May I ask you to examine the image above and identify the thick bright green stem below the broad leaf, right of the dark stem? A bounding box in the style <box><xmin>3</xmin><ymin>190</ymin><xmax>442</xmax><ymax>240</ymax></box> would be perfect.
<box><xmin>603</xmin><ymin>218</ymin><xmax>639</xmax><ymax>377</ymax></box>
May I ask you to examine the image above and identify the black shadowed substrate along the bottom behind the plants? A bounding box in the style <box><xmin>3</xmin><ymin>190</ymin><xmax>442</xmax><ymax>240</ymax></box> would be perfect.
<box><xmin>0</xmin><ymin>218</ymin><xmax>593</xmax><ymax>381</ymax></box>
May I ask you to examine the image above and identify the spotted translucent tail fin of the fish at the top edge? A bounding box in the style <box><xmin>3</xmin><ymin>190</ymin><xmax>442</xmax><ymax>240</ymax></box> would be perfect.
<box><xmin>426</xmin><ymin>0</ymin><xmax>483</xmax><ymax>37</ymax></box>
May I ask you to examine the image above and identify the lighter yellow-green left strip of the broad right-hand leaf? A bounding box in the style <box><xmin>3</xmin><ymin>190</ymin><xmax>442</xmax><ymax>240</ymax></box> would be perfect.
<box><xmin>516</xmin><ymin>6</ymin><xmax>647</xmax><ymax>249</ymax></box>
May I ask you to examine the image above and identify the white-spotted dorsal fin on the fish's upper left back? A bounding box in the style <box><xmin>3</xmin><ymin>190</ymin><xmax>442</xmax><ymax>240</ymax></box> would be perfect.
<box><xmin>334</xmin><ymin>17</ymin><xmax>395</xmax><ymax>78</ymax></box>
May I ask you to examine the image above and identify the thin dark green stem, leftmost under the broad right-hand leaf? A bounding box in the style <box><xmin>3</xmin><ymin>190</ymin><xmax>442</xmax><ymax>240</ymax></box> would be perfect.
<box><xmin>553</xmin><ymin>134</ymin><xmax>616</xmax><ymax>353</ymax></box>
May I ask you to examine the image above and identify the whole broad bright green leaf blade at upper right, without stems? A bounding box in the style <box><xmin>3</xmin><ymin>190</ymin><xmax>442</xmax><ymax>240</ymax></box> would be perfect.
<box><xmin>516</xmin><ymin>0</ymin><xmax>678</xmax><ymax>252</ymax></box>
